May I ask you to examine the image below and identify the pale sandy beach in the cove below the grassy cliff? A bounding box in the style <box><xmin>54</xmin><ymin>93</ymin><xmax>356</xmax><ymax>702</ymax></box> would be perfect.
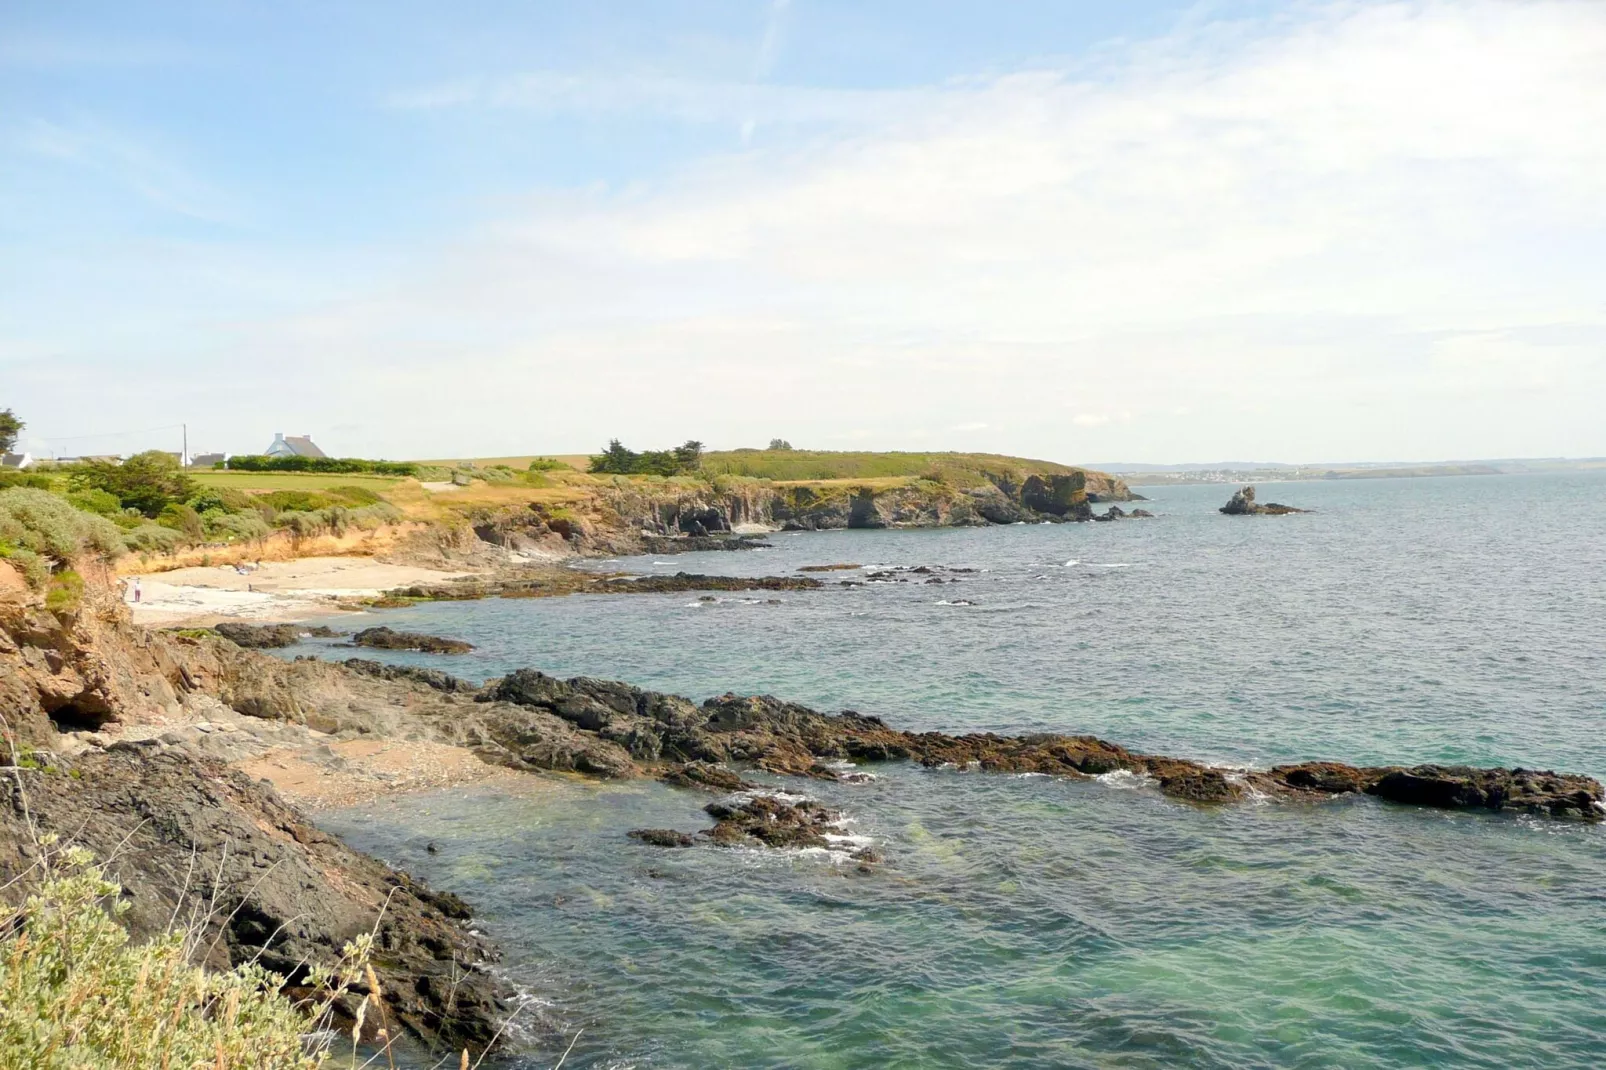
<box><xmin>124</xmin><ymin>557</ymin><xmax>472</xmax><ymax>627</ymax></box>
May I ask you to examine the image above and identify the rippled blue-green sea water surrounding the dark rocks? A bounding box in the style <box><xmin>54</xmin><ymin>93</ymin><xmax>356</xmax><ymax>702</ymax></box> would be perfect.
<box><xmin>313</xmin><ymin>476</ymin><xmax>1606</xmax><ymax>1067</ymax></box>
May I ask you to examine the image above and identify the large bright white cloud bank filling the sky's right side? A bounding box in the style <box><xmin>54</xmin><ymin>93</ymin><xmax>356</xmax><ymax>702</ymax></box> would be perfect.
<box><xmin>12</xmin><ymin>0</ymin><xmax>1606</xmax><ymax>461</ymax></box>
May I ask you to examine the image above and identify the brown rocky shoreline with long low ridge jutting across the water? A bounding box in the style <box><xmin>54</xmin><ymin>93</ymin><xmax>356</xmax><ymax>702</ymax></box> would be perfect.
<box><xmin>0</xmin><ymin>577</ymin><xmax>1606</xmax><ymax>1046</ymax></box>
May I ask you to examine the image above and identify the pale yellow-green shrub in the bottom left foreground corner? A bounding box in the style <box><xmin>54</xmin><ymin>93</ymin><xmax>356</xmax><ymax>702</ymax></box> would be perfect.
<box><xmin>0</xmin><ymin>835</ymin><xmax>373</xmax><ymax>1070</ymax></box>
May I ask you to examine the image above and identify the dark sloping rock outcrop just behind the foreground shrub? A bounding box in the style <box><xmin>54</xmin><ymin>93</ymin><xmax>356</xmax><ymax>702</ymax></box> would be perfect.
<box><xmin>0</xmin><ymin>749</ymin><xmax>514</xmax><ymax>1047</ymax></box>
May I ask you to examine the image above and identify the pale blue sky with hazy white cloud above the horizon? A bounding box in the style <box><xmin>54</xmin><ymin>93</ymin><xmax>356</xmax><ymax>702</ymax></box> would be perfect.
<box><xmin>0</xmin><ymin>0</ymin><xmax>1606</xmax><ymax>463</ymax></box>
